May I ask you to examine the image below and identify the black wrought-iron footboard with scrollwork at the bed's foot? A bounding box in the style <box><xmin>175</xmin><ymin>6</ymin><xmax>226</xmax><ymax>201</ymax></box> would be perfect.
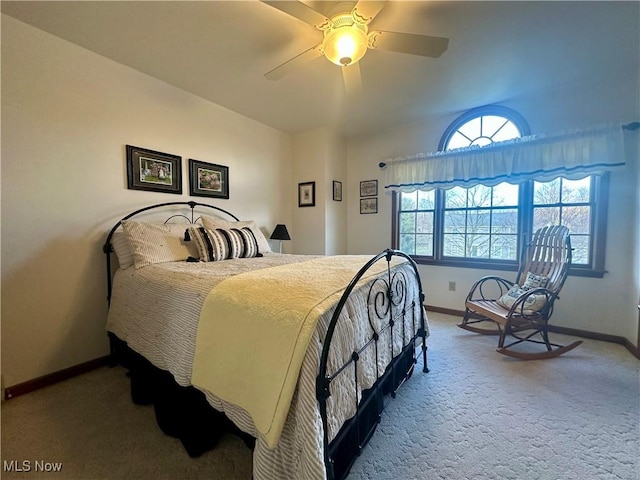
<box><xmin>316</xmin><ymin>250</ymin><xmax>429</xmax><ymax>480</ymax></box>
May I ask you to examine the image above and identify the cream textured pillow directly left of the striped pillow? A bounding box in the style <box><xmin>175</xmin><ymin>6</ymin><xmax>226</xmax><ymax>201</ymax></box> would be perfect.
<box><xmin>122</xmin><ymin>220</ymin><xmax>198</xmax><ymax>268</ymax></box>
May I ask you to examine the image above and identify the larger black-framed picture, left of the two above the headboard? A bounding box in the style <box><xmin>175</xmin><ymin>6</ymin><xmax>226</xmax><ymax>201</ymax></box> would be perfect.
<box><xmin>127</xmin><ymin>145</ymin><xmax>182</xmax><ymax>194</ymax></box>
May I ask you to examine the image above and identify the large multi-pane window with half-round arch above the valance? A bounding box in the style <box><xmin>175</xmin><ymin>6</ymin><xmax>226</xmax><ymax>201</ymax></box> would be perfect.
<box><xmin>393</xmin><ymin>106</ymin><xmax>607</xmax><ymax>276</ymax></box>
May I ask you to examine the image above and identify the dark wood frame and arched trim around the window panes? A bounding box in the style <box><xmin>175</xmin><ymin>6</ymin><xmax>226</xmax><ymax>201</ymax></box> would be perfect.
<box><xmin>391</xmin><ymin>105</ymin><xmax>609</xmax><ymax>278</ymax></box>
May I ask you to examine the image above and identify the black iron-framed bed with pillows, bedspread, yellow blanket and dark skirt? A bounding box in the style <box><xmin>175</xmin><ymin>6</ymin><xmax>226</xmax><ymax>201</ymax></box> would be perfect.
<box><xmin>103</xmin><ymin>202</ymin><xmax>428</xmax><ymax>480</ymax></box>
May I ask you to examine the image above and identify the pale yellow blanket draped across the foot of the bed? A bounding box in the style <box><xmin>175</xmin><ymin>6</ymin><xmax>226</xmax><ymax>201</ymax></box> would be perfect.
<box><xmin>192</xmin><ymin>255</ymin><xmax>398</xmax><ymax>447</ymax></box>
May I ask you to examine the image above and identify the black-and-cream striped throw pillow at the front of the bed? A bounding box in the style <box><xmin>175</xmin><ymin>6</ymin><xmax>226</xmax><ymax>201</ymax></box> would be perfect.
<box><xmin>188</xmin><ymin>227</ymin><xmax>262</xmax><ymax>262</ymax></box>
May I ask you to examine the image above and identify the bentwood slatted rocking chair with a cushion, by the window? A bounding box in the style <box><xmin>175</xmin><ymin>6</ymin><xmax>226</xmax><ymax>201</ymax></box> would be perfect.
<box><xmin>458</xmin><ymin>225</ymin><xmax>582</xmax><ymax>360</ymax></box>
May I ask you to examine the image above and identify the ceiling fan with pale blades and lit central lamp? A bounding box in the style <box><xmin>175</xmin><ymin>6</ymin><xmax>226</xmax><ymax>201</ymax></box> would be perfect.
<box><xmin>262</xmin><ymin>0</ymin><xmax>449</xmax><ymax>91</ymax></box>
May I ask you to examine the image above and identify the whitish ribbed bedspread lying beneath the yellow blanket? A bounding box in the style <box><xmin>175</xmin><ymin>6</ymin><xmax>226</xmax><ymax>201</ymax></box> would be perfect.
<box><xmin>107</xmin><ymin>253</ymin><xmax>430</xmax><ymax>480</ymax></box>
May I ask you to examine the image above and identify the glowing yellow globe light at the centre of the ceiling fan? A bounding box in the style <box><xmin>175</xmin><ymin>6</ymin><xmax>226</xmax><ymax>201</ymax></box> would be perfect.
<box><xmin>322</xmin><ymin>23</ymin><xmax>368</xmax><ymax>67</ymax></box>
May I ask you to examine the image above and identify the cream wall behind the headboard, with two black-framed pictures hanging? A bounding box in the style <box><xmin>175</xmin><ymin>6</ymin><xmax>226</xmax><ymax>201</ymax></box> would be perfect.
<box><xmin>1</xmin><ymin>15</ymin><xmax>292</xmax><ymax>386</ymax></box>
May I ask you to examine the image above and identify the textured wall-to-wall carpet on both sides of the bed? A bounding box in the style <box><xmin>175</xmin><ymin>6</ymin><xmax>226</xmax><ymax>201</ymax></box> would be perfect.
<box><xmin>1</xmin><ymin>314</ymin><xmax>640</xmax><ymax>480</ymax></box>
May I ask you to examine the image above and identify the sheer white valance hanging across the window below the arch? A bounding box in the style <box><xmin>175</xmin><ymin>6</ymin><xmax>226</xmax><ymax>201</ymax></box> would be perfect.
<box><xmin>383</xmin><ymin>124</ymin><xmax>625</xmax><ymax>191</ymax></box>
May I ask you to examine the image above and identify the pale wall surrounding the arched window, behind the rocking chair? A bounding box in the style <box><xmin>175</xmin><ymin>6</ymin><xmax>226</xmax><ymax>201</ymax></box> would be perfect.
<box><xmin>348</xmin><ymin>70</ymin><xmax>640</xmax><ymax>344</ymax></box>
